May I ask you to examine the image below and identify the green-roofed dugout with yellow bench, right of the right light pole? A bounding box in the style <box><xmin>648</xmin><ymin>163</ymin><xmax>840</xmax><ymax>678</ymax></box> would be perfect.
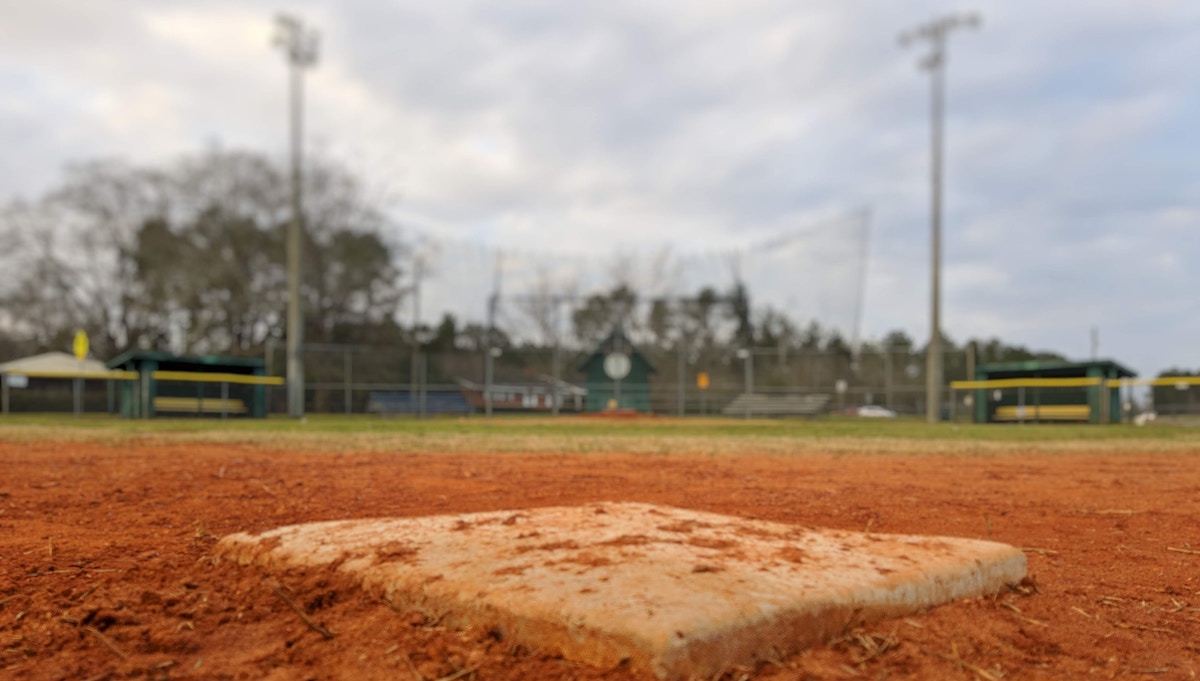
<box><xmin>958</xmin><ymin>360</ymin><xmax>1136</xmax><ymax>423</ymax></box>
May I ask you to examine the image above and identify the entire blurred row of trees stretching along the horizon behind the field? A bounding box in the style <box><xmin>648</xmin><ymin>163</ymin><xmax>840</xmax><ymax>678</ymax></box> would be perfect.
<box><xmin>0</xmin><ymin>150</ymin><xmax>1080</xmax><ymax>398</ymax></box>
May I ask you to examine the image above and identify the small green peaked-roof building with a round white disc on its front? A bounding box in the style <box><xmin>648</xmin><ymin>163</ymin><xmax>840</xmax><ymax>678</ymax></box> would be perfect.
<box><xmin>575</xmin><ymin>325</ymin><xmax>658</xmax><ymax>411</ymax></box>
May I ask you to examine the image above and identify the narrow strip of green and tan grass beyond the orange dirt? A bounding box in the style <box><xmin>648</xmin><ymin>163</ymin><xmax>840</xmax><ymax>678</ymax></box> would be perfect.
<box><xmin>0</xmin><ymin>415</ymin><xmax>1200</xmax><ymax>456</ymax></box>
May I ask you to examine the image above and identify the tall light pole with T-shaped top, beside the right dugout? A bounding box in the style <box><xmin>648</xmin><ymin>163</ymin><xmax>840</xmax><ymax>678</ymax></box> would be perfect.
<box><xmin>900</xmin><ymin>14</ymin><xmax>979</xmax><ymax>423</ymax></box>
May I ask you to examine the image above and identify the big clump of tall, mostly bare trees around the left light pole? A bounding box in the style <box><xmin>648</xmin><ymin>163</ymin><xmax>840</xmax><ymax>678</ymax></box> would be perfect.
<box><xmin>0</xmin><ymin>151</ymin><xmax>403</xmax><ymax>357</ymax></box>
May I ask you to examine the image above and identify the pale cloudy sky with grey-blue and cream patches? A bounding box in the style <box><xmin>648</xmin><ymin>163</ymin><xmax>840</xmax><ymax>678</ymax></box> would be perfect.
<box><xmin>0</xmin><ymin>0</ymin><xmax>1200</xmax><ymax>373</ymax></box>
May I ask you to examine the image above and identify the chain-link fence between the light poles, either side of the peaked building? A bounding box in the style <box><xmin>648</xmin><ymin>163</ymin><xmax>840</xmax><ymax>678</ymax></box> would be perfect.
<box><xmin>253</xmin><ymin>345</ymin><xmax>970</xmax><ymax>418</ymax></box>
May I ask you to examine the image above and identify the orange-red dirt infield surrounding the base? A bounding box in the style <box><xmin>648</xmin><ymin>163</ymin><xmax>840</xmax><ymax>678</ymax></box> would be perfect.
<box><xmin>0</xmin><ymin>438</ymin><xmax>1200</xmax><ymax>681</ymax></box>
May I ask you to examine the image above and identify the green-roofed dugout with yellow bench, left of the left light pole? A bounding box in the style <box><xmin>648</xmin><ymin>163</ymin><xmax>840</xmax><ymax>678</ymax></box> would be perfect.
<box><xmin>108</xmin><ymin>350</ymin><xmax>282</xmax><ymax>418</ymax></box>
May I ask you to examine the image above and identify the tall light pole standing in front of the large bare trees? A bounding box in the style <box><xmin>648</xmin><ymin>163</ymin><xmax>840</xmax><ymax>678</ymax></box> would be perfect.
<box><xmin>275</xmin><ymin>14</ymin><xmax>317</xmax><ymax>418</ymax></box>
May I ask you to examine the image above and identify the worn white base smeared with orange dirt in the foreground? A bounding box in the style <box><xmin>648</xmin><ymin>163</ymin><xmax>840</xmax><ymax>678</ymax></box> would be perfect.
<box><xmin>216</xmin><ymin>502</ymin><xmax>1026</xmax><ymax>680</ymax></box>
